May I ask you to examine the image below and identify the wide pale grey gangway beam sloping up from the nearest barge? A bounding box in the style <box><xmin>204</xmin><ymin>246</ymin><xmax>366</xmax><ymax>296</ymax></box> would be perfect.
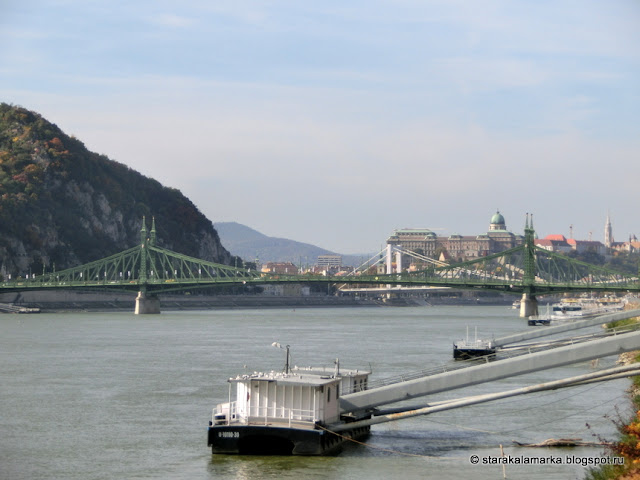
<box><xmin>340</xmin><ymin>310</ymin><xmax>640</xmax><ymax>413</ymax></box>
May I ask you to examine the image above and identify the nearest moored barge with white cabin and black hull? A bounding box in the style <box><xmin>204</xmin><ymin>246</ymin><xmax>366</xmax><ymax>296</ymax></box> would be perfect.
<box><xmin>208</xmin><ymin>361</ymin><xmax>370</xmax><ymax>455</ymax></box>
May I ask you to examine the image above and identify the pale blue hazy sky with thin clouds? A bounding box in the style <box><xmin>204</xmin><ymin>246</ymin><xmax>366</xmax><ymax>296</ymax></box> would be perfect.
<box><xmin>0</xmin><ymin>0</ymin><xmax>640</xmax><ymax>253</ymax></box>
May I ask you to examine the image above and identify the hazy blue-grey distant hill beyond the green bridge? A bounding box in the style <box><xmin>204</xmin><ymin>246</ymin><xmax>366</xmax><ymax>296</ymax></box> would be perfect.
<box><xmin>214</xmin><ymin>222</ymin><xmax>368</xmax><ymax>266</ymax></box>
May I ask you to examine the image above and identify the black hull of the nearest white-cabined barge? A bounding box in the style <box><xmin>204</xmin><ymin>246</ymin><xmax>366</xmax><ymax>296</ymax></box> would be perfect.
<box><xmin>208</xmin><ymin>425</ymin><xmax>370</xmax><ymax>455</ymax></box>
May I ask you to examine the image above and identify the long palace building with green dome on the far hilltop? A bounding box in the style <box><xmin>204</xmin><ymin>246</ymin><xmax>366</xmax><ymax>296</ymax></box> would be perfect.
<box><xmin>387</xmin><ymin>210</ymin><xmax>524</xmax><ymax>268</ymax></box>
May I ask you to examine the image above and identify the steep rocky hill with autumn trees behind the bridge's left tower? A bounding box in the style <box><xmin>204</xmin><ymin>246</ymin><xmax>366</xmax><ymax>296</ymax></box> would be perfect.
<box><xmin>0</xmin><ymin>104</ymin><xmax>232</xmax><ymax>277</ymax></box>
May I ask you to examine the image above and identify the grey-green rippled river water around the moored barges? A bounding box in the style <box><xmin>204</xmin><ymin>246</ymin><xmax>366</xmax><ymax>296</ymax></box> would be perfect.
<box><xmin>0</xmin><ymin>306</ymin><xmax>630</xmax><ymax>480</ymax></box>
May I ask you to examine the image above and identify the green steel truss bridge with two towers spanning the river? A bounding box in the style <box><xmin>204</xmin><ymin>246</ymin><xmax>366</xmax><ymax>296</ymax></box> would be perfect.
<box><xmin>0</xmin><ymin>217</ymin><xmax>640</xmax><ymax>314</ymax></box>
